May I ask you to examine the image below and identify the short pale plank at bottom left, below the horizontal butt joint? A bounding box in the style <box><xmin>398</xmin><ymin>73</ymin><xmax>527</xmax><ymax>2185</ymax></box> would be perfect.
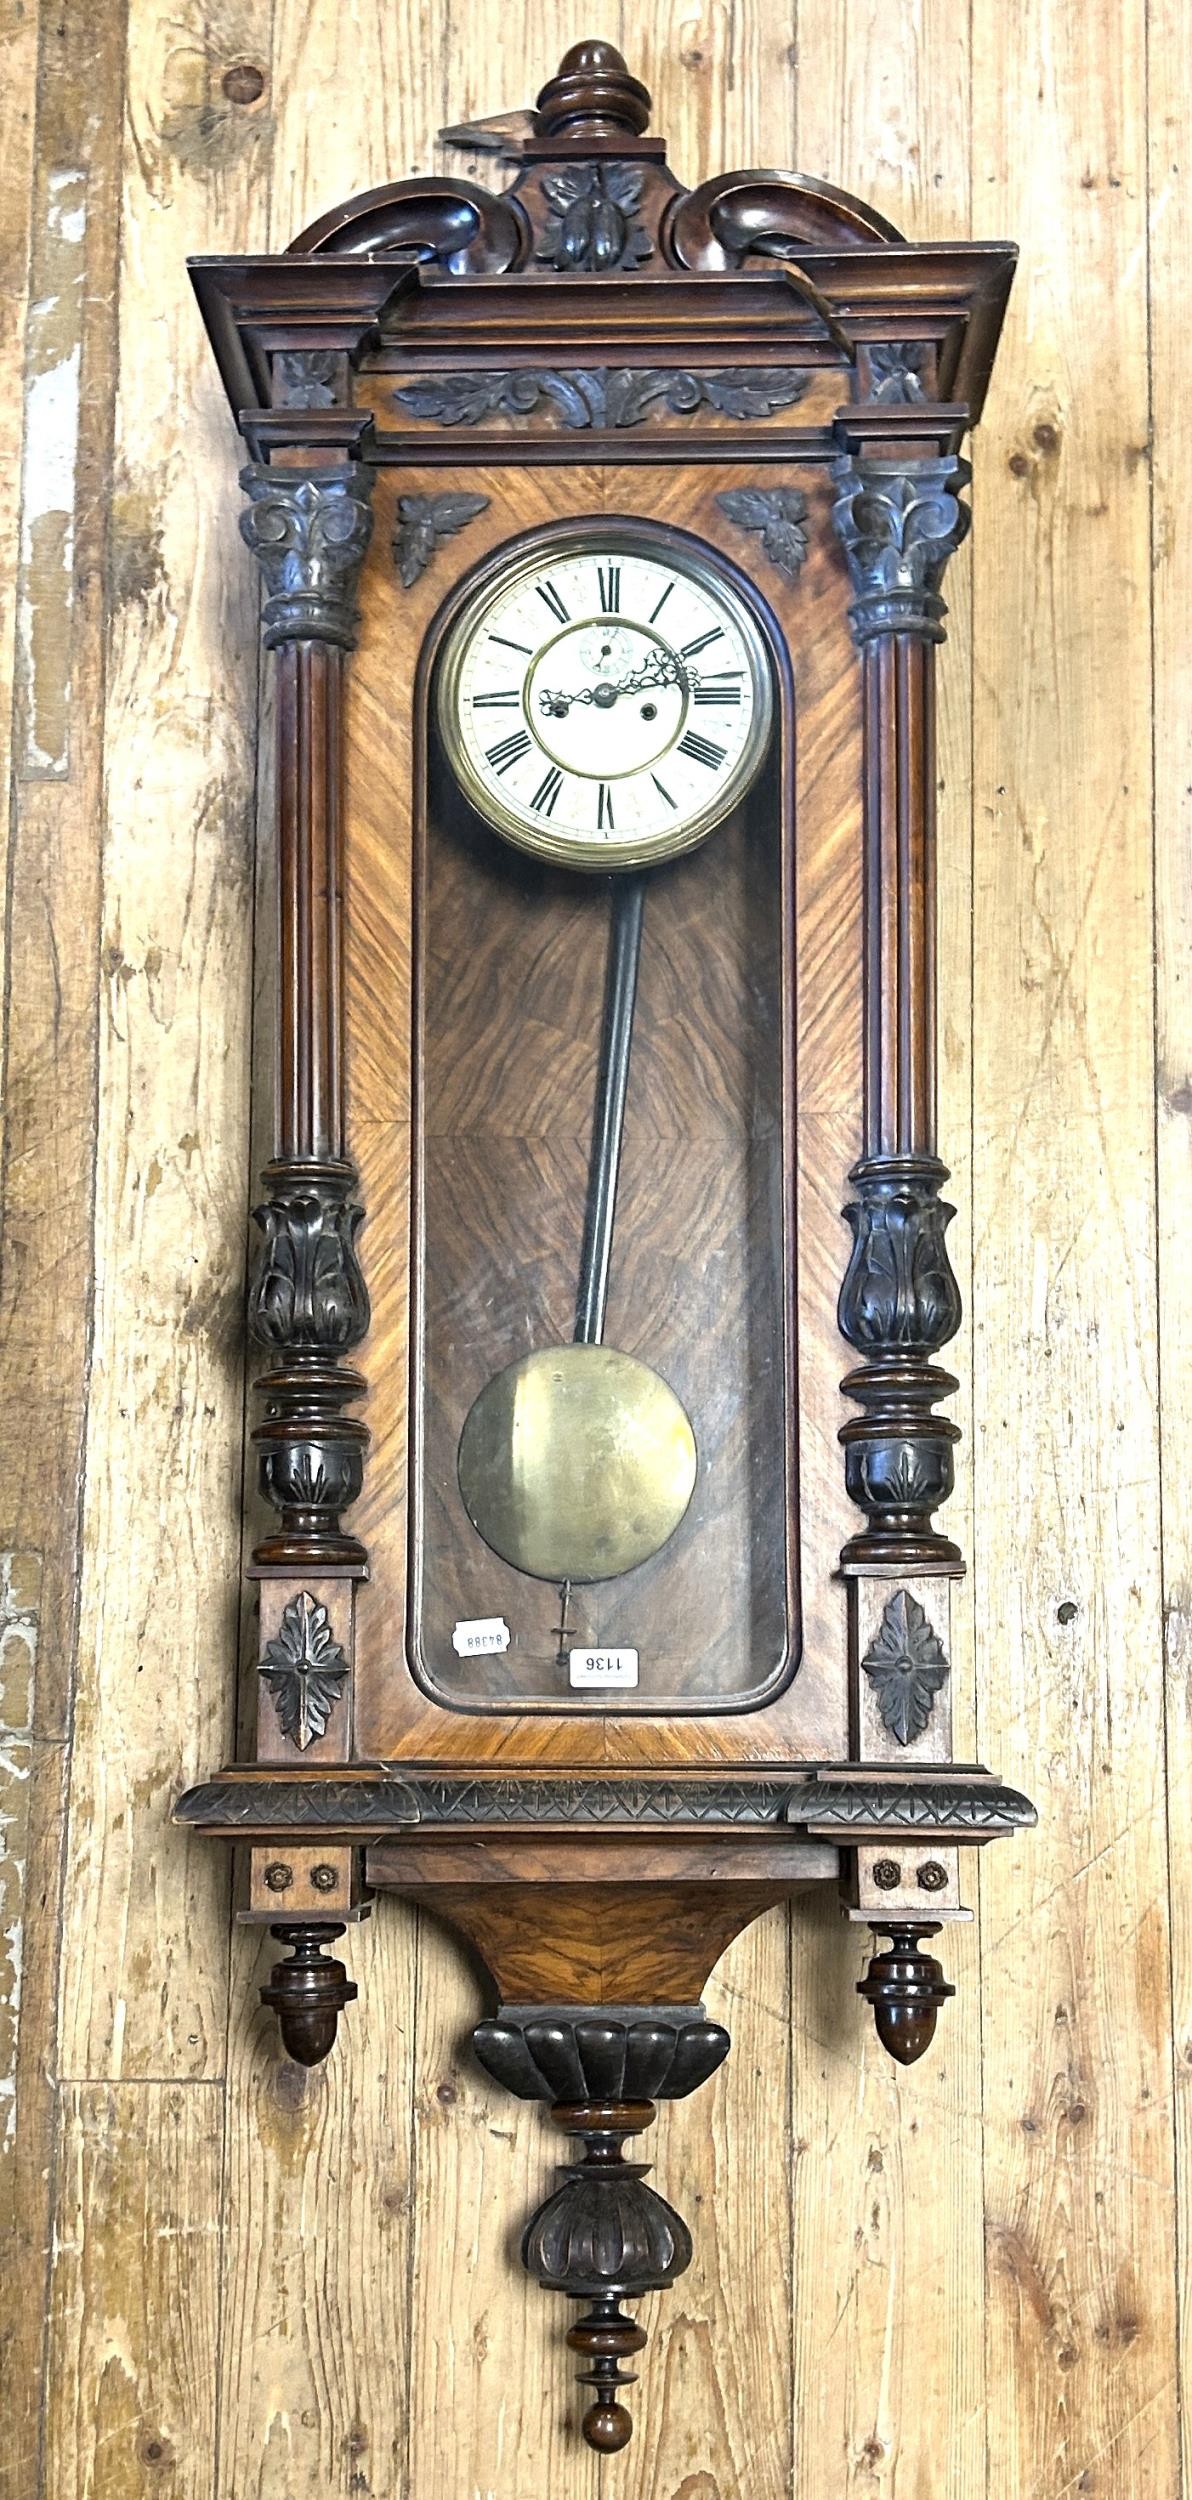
<box><xmin>41</xmin><ymin>2083</ymin><xmax>222</xmax><ymax>2500</ymax></box>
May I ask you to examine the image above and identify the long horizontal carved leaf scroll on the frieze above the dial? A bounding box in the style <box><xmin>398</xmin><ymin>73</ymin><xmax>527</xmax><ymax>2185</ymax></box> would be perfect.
<box><xmin>395</xmin><ymin>365</ymin><xmax>810</xmax><ymax>430</ymax></box>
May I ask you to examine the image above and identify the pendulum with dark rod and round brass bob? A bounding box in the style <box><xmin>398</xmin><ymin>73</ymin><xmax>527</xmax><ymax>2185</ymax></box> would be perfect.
<box><xmin>457</xmin><ymin>875</ymin><xmax>697</xmax><ymax>1585</ymax></box>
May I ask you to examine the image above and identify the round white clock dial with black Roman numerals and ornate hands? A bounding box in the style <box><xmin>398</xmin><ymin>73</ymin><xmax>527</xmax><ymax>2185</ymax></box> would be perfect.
<box><xmin>437</xmin><ymin>525</ymin><xmax>772</xmax><ymax>870</ymax></box>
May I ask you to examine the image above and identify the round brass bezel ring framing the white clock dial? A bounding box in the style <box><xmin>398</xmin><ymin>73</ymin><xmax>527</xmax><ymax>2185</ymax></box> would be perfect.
<box><xmin>435</xmin><ymin>515</ymin><xmax>775</xmax><ymax>875</ymax></box>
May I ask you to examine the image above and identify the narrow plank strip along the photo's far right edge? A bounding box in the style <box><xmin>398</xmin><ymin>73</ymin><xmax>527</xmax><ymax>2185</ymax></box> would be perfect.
<box><xmin>1147</xmin><ymin>0</ymin><xmax>1192</xmax><ymax>2490</ymax></box>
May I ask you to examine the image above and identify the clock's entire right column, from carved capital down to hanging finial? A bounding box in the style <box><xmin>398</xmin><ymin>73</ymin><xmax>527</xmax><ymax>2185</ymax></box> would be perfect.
<box><xmin>832</xmin><ymin>408</ymin><xmax>970</xmax><ymax>2063</ymax></box>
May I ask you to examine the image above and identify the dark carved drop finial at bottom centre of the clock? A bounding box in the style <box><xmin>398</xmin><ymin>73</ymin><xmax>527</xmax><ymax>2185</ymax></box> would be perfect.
<box><xmin>472</xmin><ymin>2005</ymin><xmax>730</xmax><ymax>2453</ymax></box>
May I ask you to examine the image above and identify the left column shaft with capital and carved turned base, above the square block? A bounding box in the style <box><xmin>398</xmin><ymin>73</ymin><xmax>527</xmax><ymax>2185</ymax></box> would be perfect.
<box><xmin>240</xmin><ymin>465</ymin><xmax>372</xmax><ymax>1570</ymax></box>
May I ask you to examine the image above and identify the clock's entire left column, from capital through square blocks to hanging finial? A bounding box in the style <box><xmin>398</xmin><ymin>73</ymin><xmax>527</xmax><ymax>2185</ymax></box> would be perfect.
<box><xmin>240</xmin><ymin>463</ymin><xmax>372</xmax><ymax>2065</ymax></box>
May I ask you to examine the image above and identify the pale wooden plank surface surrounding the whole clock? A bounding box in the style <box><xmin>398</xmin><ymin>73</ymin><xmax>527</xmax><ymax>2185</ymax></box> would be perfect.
<box><xmin>0</xmin><ymin>0</ymin><xmax>1192</xmax><ymax>2500</ymax></box>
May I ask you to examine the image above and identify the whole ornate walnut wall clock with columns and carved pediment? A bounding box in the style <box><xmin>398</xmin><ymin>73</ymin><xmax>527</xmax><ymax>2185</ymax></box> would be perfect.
<box><xmin>177</xmin><ymin>43</ymin><xmax>1032</xmax><ymax>2450</ymax></box>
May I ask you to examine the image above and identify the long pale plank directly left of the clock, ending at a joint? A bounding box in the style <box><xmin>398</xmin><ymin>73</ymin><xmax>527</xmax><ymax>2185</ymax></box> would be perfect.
<box><xmin>62</xmin><ymin>0</ymin><xmax>267</xmax><ymax>2078</ymax></box>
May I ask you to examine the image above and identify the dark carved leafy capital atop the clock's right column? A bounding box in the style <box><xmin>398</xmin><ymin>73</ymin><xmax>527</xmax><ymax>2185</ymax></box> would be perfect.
<box><xmin>832</xmin><ymin>453</ymin><xmax>972</xmax><ymax>643</ymax></box>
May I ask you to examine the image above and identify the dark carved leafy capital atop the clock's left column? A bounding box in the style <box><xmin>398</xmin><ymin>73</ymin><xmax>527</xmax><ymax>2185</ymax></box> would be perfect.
<box><xmin>240</xmin><ymin>463</ymin><xmax>372</xmax><ymax>650</ymax></box>
